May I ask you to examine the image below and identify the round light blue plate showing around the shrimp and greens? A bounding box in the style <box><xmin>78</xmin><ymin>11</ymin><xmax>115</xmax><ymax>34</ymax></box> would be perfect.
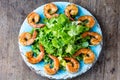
<box><xmin>18</xmin><ymin>2</ymin><xmax>103</xmax><ymax>79</ymax></box>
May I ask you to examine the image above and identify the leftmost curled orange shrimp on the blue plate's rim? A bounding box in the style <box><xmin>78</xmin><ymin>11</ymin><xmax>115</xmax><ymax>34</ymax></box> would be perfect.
<box><xmin>19</xmin><ymin>31</ymin><xmax>37</xmax><ymax>46</ymax></box>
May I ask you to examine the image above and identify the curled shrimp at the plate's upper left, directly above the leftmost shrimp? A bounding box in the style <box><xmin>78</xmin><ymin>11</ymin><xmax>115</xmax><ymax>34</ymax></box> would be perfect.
<box><xmin>27</xmin><ymin>12</ymin><xmax>45</xmax><ymax>28</ymax></box>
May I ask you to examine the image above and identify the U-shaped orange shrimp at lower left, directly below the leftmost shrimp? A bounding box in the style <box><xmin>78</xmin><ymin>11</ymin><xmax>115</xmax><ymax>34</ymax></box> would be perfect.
<box><xmin>26</xmin><ymin>45</ymin><xmax>45</xmax><ymax>64</ymax></box>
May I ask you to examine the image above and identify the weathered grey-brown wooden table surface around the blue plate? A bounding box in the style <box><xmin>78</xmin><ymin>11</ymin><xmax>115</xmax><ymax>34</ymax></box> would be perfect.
<box><xmin>0</xmin><ymin>0</ymin><xmax>120</xmax><ymax>80</ymax></box>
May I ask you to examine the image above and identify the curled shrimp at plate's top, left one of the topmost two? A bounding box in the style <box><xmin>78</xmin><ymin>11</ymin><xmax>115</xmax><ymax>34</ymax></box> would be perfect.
<box><xmin>44</xmin><ymin>3</ymin><xmax>58</xmax><ymax>19</ymax></box>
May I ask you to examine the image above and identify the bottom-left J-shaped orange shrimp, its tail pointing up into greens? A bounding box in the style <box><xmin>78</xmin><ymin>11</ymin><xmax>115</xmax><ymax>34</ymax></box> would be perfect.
<box><xmin>44</xmin><ymin>55</ymin><xmax>60</xmax><ymax>75</ymax></box>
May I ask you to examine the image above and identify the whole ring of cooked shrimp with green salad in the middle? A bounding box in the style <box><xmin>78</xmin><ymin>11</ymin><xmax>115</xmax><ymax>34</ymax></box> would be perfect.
<box><xmin>18</xmin><ymin>3</ymin><xmax>102</xmax><ymax>79</ymax></box>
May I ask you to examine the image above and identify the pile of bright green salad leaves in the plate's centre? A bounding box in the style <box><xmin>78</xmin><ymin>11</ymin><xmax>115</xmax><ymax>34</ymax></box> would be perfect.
<box><xmin>32</xmin><ymin>14</ymin><xmax>90</xmax><ymax>68</ymax></box>
